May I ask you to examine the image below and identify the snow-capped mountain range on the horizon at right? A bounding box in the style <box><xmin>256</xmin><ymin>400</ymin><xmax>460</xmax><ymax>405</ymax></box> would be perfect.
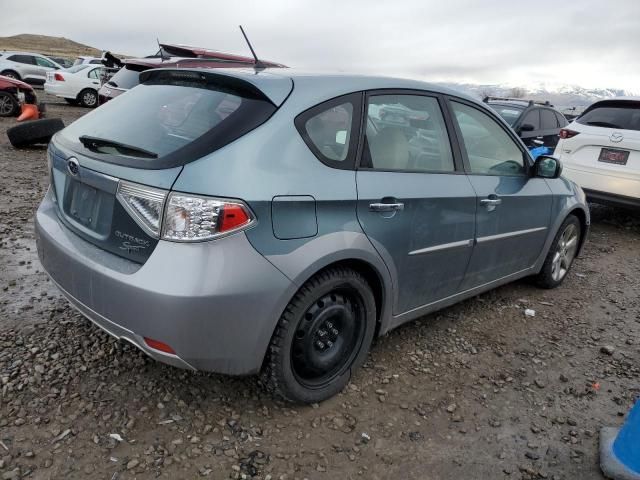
<box><xmin>441</xmin><ymin>83</ymin><xmax>638</xmax><ymax>108</ymax></box>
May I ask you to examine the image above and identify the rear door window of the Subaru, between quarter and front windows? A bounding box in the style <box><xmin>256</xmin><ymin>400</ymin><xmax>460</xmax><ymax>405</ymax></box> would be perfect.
<box><xmin>362</xmin><ymin>95</ymin><xmax>455</xmax><ymax>172</ymax></box>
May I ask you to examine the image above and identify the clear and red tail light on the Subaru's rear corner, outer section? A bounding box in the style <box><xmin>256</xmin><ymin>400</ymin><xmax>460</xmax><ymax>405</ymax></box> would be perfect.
<box><xmin>162</xmin><ymin>193</ymin><xmax>255</xmax><ymax>242</ymax></box>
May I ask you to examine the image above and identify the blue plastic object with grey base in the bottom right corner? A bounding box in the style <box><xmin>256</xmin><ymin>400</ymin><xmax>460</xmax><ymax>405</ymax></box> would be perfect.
<box><xmin>600</xmin><ymin>400</ymin><xmax>640</xmax><ymax>480</ymax></box>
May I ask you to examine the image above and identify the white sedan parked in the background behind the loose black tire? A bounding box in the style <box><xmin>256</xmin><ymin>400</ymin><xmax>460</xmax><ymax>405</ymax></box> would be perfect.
<box><xmin>44</xmin><ymin>64</ymin><xmax>104</xmax><ymax>108</ymax></box>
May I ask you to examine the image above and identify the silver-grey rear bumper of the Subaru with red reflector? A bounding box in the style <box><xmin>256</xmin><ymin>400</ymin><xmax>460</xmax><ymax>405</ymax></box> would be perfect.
<box><xmin>36</xmin><ymin>192</ymin><xmax>296</xmax><ymax>375</ymax></box>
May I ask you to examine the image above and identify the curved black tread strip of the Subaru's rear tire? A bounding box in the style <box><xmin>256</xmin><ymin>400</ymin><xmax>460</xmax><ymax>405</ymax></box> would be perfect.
<box><xmin>260</xmin><ymin>267</ymin><xmax>370</xmax><ymax>403</ymax></box>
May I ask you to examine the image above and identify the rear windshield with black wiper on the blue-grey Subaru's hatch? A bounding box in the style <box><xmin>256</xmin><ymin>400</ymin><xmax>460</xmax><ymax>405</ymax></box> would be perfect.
<box><xmin>60</xmin><ymin>71</ymin><xmax>275</xmax><ymax>168</ymax></box>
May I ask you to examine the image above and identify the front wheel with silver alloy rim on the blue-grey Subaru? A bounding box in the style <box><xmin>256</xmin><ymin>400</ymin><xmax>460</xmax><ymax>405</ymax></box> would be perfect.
<box><xmin>535</xmin><ymin>215</ymin><xmax>582</xmax><ymax>288</ymax></box>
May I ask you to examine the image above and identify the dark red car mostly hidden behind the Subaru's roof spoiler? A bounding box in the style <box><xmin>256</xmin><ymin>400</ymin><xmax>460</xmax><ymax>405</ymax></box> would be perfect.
<box><xmin>98</xmin><ymin>43</ymin><xmax>286</xmax><ymax>104</ymax></box>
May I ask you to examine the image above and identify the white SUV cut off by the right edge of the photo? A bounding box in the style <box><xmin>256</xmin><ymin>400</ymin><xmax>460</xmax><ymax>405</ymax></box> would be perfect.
<box><xmin>555</xmin><ymin>97</ymin><xmax>640</xmax><ymax>207</ymax></box>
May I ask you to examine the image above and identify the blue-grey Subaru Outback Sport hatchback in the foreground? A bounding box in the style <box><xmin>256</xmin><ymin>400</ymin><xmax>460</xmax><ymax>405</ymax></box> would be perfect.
<box><xmin>36</xmin><ymin>69</ymin><xmax>589</xmax><ymax>402</ymax></box>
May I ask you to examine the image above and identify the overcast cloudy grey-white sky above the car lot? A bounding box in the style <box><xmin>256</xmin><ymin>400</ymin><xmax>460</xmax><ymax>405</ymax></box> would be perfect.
<box><xmin>5</xmin><ymin>0</ymin><xmax>640</xmax><ymax>93</ymax></box>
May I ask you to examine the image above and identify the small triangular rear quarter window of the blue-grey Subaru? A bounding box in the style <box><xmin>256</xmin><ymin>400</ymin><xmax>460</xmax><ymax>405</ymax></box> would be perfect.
<box><xmin>295</xmin><ymin>94</ymin><xmax>362</xmax><ymax>169</ymax></box>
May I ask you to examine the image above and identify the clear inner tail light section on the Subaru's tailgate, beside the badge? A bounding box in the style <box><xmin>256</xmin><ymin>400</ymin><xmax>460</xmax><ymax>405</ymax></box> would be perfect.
<box><xmin>116</xmin><ymin>182</ymin><xmax>167</xmax><ymax>238</ymax></box>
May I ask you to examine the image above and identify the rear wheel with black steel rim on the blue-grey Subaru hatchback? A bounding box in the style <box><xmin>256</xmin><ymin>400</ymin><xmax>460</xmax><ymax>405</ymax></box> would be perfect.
<box><xmin>262</xmin><ymin>268</ymin><xmax>376</xmax><ymax>403</ymax></box>
